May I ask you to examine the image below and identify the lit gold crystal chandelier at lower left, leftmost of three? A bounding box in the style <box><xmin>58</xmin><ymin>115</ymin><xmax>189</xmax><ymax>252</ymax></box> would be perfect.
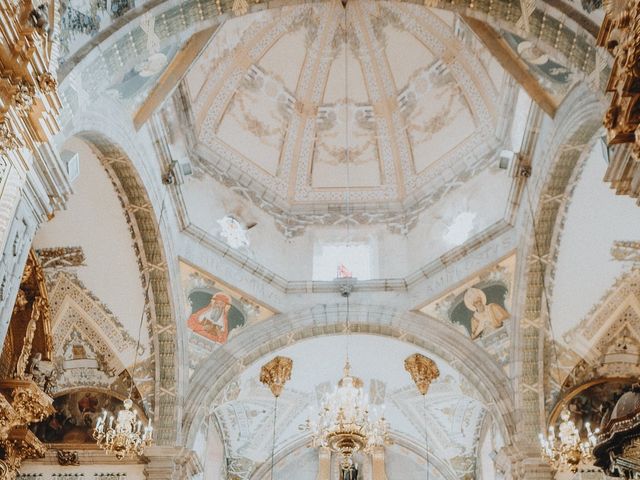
<box><xmin>93</xmin><ymin>398</ymin><xmax>153</xmax><ymax>460</ymax></box>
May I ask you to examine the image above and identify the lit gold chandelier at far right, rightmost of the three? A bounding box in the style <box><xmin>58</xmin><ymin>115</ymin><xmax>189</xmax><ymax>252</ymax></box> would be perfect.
<box><xmin>540</xmin><ymin>407</ymin><xmax>600</xmax><ymax>472</ymax></box>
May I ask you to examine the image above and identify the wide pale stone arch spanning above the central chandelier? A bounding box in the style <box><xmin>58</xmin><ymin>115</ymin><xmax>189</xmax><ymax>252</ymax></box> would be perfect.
<box><xmin>183</xmin><ymin>304</ymin><xmax>516</xmax><ymax>454</ymax></box>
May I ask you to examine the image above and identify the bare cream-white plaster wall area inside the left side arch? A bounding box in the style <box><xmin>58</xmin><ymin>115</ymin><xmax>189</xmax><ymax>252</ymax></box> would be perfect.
<box><xmin>34</xmin><ymin>139</ymin><xmax>148</xmax><ymax>365</ymax></box>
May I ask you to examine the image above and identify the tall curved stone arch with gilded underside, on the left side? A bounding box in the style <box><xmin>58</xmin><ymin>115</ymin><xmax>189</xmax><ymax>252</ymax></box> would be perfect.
<box><xmin>52</xmin><ymin>108</ymin><xmax>182</xmax><ymax>445</ymax></box>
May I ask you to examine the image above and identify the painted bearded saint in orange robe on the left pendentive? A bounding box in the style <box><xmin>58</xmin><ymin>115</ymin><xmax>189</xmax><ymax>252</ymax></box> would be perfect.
<box><xmin>187</xmin><ymin>291</ymin><xmax>245</xmax><ymax>343</ymax></box>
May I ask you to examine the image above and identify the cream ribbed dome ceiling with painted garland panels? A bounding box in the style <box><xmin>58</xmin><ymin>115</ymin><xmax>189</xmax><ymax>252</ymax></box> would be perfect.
<box><xmin>184</xmin><ymin>0</ymin><xmax>509</xmax><ymax>211</ymax></box>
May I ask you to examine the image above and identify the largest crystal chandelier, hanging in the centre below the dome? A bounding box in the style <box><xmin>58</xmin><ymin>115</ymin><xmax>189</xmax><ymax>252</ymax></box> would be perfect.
<box><xmin>301</xmin><ymin>361</ymin><xmax>389</xmax><ymax>470</ymax></box>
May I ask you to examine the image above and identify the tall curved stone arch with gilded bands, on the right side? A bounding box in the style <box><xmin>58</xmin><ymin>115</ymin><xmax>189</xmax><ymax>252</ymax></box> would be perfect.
<box><xmin>516</xmin><ymin>85</ymin><xmax>603</xmax><ymax>445</ymax></box>
